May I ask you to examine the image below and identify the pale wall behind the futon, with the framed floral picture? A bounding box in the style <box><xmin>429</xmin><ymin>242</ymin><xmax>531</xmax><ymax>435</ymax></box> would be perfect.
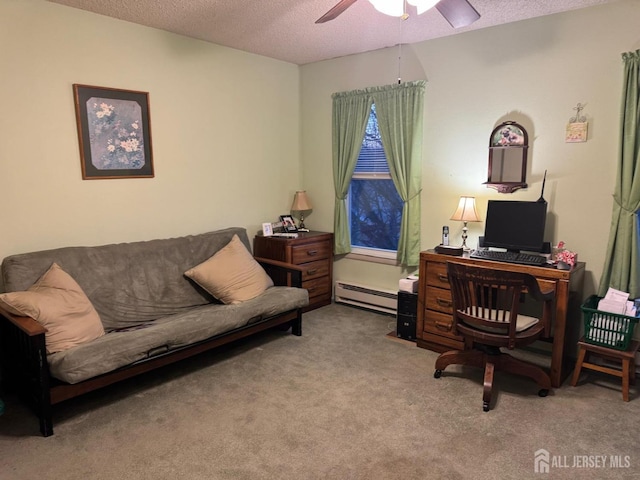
<box><xmin>0</xmin><ymin>0</ymin><xmax>302</xmax><ymax>266</ymax></box>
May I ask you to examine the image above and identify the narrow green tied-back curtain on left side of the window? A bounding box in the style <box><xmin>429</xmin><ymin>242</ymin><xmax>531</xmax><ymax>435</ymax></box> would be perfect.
<box><xmin>332</xmin><ymin>90</ymin><xmax>373</xmax><ymax>255</ymax></box>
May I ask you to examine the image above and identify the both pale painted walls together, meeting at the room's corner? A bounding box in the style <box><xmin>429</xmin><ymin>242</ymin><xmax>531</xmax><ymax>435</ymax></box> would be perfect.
<box><xmin>0</xmin><ymin>0</ymin><xmax>640</xmax><ymax>300</ymax></box>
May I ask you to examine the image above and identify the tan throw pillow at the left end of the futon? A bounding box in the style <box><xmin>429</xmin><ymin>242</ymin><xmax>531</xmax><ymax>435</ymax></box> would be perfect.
<box><xmin>0</xmin><ymin>263</ymin><xmax>104</xmax><ymax>353</ymax></box>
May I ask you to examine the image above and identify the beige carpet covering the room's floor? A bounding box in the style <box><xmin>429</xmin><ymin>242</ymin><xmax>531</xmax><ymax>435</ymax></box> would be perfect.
<box><xmin>0</xmin><ymin>305</ymin><xmax>640</xmax><ymax>480</ymax></box>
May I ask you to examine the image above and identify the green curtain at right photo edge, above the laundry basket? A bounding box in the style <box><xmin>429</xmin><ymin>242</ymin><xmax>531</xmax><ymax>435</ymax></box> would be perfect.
<box><xmin>598</xmin><ymin>50</ymin><xmax>640</xmax><ymax>298</ymax></box>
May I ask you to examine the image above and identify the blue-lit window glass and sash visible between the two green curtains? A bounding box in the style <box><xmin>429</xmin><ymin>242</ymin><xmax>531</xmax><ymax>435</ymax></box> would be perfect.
<box><xmin>348</xmin><ymin>104</ymin><xmax>403</xmax><ymax>258</ymax></box>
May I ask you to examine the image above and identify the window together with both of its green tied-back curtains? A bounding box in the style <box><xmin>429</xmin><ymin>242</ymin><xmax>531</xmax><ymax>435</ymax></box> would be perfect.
<box><xmin>331</xmin><ymin>80</ymin><xmax>426</xmax><ymax>266</ymax></box>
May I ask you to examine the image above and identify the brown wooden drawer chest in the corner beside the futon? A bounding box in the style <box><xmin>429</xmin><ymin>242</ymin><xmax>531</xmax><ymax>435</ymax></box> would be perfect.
<box><xmin>253</xmin><ymin>232</ymin><xmax>333</xmax><ymax>312</ymax></box>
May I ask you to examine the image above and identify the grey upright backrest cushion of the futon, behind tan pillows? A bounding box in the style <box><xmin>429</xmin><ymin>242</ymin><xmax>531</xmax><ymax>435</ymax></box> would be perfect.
<box><xmin>2</xmin><ymin>228</ymin><xmax>251</xmax><ymax>331</ymax></box>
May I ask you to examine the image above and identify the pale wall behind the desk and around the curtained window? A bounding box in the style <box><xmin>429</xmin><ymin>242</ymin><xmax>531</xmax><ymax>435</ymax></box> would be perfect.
<box><xmin>301</xmin><ymin>0</ymin><xmax>640</xmax><ymax>294</ymax></box>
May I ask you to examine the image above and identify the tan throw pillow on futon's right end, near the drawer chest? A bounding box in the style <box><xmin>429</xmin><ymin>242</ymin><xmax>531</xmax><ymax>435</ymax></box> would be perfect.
<box><xmin>185</xmin><ymin>235</ymin><xmax>273</xmax><ymax>304</ymax></box>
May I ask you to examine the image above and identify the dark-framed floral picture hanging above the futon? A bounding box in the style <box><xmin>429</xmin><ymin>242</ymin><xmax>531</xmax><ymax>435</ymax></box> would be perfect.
<box><xmin>73</xmin><ymin>83</ymin><xmax>154</xmax><ymax>180</ymax></box>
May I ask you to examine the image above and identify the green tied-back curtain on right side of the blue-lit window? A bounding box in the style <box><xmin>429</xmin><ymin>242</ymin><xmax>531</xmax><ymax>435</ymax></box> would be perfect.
<box><xmin>372</xmin><ymin>80</ymin><xmax>426</xmax><ymax>266</ymax></box>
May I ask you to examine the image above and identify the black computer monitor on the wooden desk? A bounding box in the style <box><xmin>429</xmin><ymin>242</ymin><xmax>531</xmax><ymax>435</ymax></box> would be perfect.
<box><xmin>483</xmin><ymin>200</ymin><xmax>547</xmax><ymax>252</ymax></box>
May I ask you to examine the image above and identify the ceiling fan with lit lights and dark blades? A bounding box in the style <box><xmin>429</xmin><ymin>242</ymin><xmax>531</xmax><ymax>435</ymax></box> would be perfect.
<box><xmin>316</xmin><ymin>0</ymin><xmax>480</xmax><ymax>28</ymax></box>
